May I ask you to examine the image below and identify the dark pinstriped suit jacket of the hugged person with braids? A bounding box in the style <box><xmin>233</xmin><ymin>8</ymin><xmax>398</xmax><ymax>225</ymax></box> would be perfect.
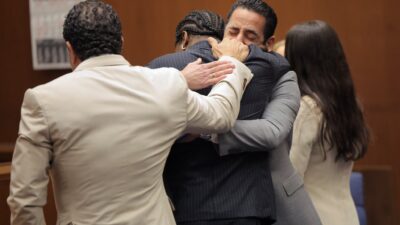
<box><xmin>149</xmin><ymin>42</ymin><xmax>290</xmax><ymax>222</ymax></box>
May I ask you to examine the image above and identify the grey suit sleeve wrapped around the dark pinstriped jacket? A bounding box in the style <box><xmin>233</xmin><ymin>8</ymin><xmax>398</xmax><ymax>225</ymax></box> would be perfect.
<box><xmin>218</xmin><ymin>71</ymin><xmax>300</xmax><ymax>156</ymax></box>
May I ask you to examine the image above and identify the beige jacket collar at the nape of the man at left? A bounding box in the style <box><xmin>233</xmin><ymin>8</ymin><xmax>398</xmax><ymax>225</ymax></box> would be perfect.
<box><xmin>74</xmin><ymin>54</ymin><xmax>130</xmax><ymax>71</ymax></box>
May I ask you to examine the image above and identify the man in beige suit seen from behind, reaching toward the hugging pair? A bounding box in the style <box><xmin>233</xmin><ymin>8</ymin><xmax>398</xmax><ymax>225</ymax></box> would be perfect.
<box><xmin>8</xmin><ymin>0</ymin><xmax>252</xmax><ymax>225</ymax></box>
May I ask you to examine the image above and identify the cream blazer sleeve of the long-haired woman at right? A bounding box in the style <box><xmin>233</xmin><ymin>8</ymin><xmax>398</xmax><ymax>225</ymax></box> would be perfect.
<box><xmin>289</xmin><ymin>98</ymin><xmax>321</xmax><ymax>177</ymax></box>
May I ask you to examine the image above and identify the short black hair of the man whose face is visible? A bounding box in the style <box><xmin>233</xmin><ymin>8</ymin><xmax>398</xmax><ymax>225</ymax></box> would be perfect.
<box><xmin>228</xmin><ymin>0</ymin><xmax>278</xmax><ymax>42</ymax></box>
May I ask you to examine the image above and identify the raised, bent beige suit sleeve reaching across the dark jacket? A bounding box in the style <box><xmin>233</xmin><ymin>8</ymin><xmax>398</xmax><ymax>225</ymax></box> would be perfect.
<box><xmin>185</xmin><ymin>56</ymin><xmax>253</xmax><ymax>133</ymax></box>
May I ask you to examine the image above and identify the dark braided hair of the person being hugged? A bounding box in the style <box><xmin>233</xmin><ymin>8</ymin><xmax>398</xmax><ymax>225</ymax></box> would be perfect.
<box><xmin>175</xmin><ymin>10</ymin><xmax>225</xmax><ymax>44</ymax></box>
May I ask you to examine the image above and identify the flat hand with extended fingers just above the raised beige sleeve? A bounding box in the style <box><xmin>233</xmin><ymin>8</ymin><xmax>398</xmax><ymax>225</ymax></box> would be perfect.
<box><xmin>181</xmin><ymin>58</ymin><xmax>235</xmax><ymax>90</ymax></box>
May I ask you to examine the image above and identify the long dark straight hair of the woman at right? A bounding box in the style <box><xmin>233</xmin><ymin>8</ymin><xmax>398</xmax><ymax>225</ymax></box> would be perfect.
<box><xmin>285</xmin><ymin>20</ymin><xmax>369</xmax><ymax>161</ymax></box>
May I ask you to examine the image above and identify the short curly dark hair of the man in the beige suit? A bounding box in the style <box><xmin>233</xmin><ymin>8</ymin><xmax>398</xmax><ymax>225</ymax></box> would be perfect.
<box><xmin>63</xmin><ymin>0</ymin><xmax>122</xmax><ymax>61</ymax></box>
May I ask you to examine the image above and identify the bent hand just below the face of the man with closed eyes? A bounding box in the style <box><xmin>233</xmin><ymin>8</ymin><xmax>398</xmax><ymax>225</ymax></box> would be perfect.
<box><xmin>208</xmin><ymin>37</ymin><xmax>249</xmax><ymax>62</ymax></box>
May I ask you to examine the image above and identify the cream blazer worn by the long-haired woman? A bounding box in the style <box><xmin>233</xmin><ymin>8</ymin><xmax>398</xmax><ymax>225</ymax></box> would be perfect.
<box><xmin>290</xmin><ymin>96</ymin><xmax>359</xmax><ymax>225</ymax></box>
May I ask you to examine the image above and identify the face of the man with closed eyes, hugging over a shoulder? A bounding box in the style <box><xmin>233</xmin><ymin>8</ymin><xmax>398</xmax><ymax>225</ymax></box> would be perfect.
<box><xmin>224</xmin><ymin>7</ymin><xmax>266</xmax><ymax>49</ymax></box>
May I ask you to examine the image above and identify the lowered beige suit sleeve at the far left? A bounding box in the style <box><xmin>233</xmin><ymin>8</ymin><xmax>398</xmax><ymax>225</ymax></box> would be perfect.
<box><xmin>7</xmin><ymin>90</ymin><xmax>52</xmax><ymax>225</ymax></box>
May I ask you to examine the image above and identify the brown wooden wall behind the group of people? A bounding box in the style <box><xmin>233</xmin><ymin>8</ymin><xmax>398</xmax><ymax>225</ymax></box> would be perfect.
<box><xmin>0</xmin><ymin>0</ymin><xmax>400</xmax><ymax>224</ymax></box>
